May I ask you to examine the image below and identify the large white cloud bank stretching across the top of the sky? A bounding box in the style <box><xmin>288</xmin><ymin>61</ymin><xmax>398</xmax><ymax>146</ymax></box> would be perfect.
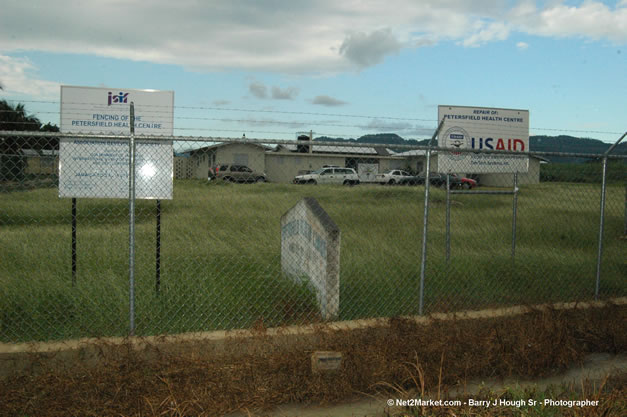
<box><xmin>0</xmin><ymin>0</ymin><xmax>627</xmax><ymax>74</ymax></box>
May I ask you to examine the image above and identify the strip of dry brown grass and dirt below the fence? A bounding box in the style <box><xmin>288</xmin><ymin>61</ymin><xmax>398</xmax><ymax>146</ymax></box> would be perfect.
<box><xmin>0</xmin><ymin>304</ymin><xmax>627</xmax><ymax>417</ymax></box>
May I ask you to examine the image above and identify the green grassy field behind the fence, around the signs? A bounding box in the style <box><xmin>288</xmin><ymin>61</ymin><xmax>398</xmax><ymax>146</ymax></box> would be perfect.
<box><xmin>0</xmin><ymin>180</ymin><xmax>627</xmax><ymax>342</ymax></box>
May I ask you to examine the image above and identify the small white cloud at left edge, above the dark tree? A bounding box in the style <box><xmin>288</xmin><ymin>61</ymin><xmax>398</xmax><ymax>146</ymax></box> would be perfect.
<box><xmin>0</xmin><ymin>55</ymin><xmax>60</xmax><ymax>98</ymax></box>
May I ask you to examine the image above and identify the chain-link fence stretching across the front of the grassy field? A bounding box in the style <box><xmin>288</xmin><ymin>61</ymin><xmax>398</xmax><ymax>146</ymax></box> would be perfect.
<box><xmin>0</xmin><ymin>132</ymin><xmax>627</xmax><ymax>342</ymax></box>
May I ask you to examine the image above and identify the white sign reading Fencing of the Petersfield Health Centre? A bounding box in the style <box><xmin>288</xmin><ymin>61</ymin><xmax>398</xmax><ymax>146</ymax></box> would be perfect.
<box><xmin>59</xmin><ymin>86</ymin><xmax>174</xmax><ymax>199</ymax></box>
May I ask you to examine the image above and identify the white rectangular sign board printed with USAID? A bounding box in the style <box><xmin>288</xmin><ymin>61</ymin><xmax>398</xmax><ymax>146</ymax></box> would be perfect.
<box><xmin>438</xmin><ymin>106</ymin><xmax>529</xmax><ymax>174</ymax></box>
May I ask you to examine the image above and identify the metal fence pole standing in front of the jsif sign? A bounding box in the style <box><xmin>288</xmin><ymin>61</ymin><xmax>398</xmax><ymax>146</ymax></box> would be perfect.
<box><xmin>128</xmin><ymin>102</ymin><xmax>135</xmax><ymax>336</ymax></box>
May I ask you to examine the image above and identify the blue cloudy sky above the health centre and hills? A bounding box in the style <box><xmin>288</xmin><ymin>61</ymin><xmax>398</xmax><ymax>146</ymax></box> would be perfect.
<box><xmin>0</xmin><ymin>0</ymin><xmax>627</xmax><ymax>142</ymax></box>
